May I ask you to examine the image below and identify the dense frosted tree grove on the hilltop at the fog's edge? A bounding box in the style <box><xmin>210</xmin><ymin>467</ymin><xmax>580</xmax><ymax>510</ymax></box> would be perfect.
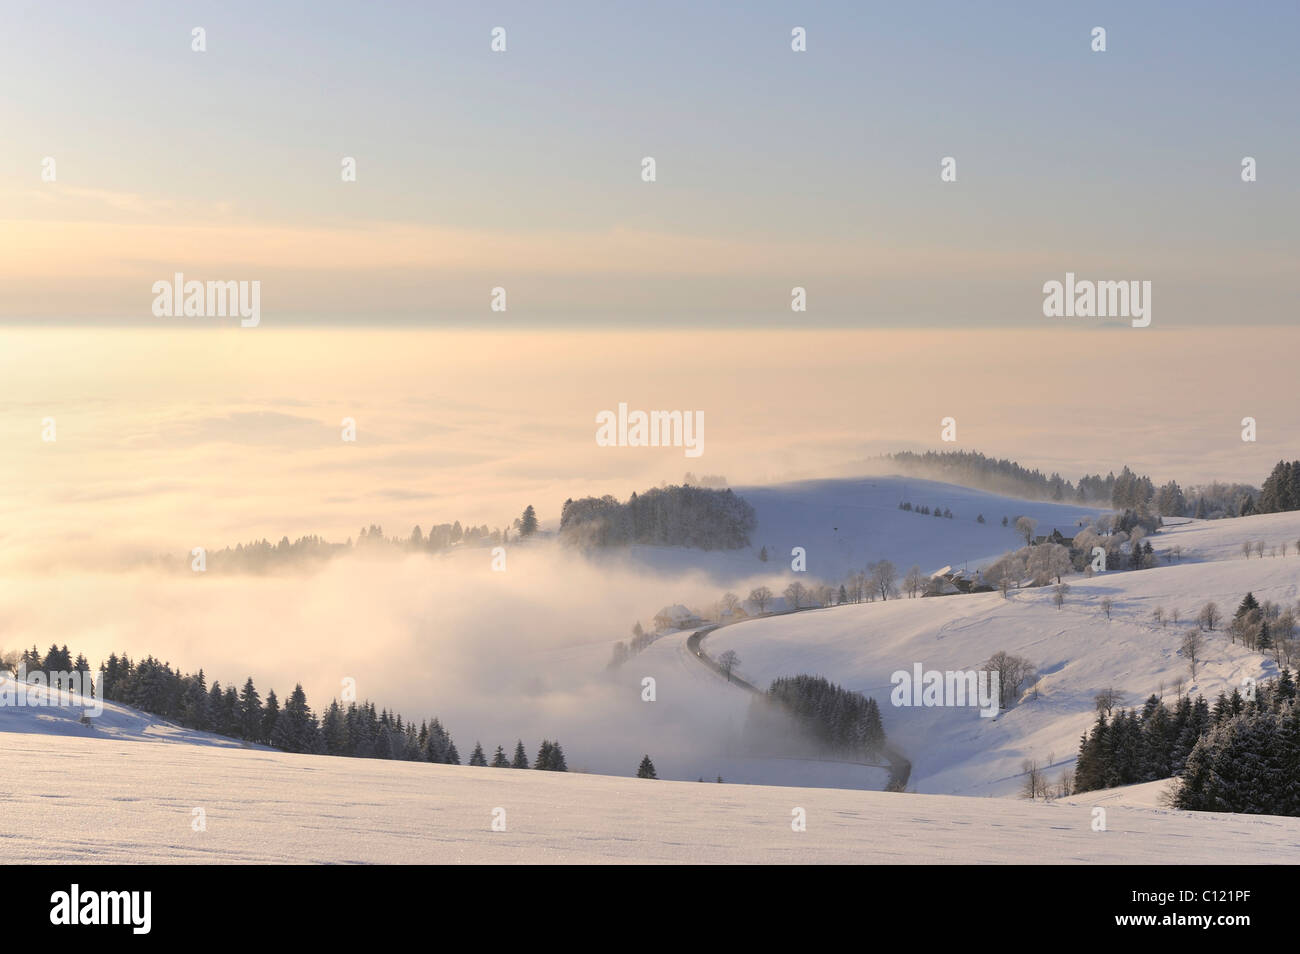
<box><xmin>560</xmin><ymin>485</ymin><xmax>757</xmax><ymax>550</ymax></box>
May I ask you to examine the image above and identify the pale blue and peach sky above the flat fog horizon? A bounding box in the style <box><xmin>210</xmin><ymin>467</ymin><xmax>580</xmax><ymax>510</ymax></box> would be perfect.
<box><xmin>0</xmin><ymin>0</ymin><xmax>1300</xmax><ymax>329</ymax></box>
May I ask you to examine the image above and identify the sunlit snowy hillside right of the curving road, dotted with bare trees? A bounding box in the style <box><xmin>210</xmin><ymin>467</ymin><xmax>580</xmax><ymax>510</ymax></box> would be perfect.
<box><xmin>706</xmin><ymin>513</ymin><xmax>1300</xmax><ymax>795</ymax></box>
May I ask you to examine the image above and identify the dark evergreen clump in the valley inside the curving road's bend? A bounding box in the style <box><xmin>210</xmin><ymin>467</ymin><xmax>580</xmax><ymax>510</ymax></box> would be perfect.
<box><xmin>745</xmin><ymin>676</ymin><xmax>885</xmax><ymax>759</ymax></box>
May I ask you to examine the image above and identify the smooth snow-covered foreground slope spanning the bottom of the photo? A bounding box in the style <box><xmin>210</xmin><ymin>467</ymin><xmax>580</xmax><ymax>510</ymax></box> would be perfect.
<box><xmin>0</xmin><ymin>733</ymin><xmax>1300</xmax><ymax>864</ymax></box>
